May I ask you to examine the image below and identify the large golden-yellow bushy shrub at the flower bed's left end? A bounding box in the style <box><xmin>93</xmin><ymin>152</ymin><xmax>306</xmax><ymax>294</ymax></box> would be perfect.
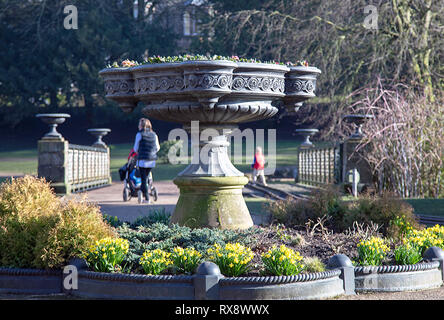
<box><xmin>0</xmin><ymin>176</ymin><xmax>115</xmax><ymax>268</ymax></box>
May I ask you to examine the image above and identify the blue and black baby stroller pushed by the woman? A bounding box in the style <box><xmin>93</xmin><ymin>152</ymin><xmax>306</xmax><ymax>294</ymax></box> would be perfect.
<box><xmin>119</xmin><ymin>155</ymin><xmax>157</xmax><ymax>203</ymax></box>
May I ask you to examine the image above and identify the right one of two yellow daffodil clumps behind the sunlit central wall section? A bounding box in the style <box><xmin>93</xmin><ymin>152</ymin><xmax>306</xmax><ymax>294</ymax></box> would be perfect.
<box><xmin>261</xmin><ymin>245</ymin><xmax>304</xmax><ymax>276</ymax></box>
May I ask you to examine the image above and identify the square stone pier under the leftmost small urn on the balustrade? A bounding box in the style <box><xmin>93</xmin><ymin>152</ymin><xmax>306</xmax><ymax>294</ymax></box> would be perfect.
<box><xmin>37</xmin><ymin>137</ymin><xmax>71</xmax><ymax>194</ymax></box>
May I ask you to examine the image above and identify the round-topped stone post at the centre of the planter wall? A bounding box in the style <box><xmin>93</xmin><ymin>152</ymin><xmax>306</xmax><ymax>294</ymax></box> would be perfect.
<box><xmin>194</xmin><ymin>261</ymin><xmax>223</xmax><ymax>300</ymax></box>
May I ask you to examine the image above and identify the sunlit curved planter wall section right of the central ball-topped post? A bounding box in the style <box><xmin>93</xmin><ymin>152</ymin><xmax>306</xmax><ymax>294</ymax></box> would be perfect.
<box><xmin>219</xmin><ymin>270</ymin><xmax>344</xmax><ymax>300</ymax></box>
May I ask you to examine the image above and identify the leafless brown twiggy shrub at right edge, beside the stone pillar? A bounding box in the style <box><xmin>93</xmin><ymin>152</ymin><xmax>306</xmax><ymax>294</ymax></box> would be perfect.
<box><xmin>350</xmin><ymin>80</ymin><xmax>444</xmax><ymax>197</ymax></box>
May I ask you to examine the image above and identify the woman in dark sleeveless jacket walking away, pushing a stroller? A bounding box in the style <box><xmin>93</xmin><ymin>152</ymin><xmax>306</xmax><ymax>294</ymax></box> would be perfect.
<box><xmin>133</xmin><ymin>118</ymin><xmax>160</xmax><ymax>202</ymax></box>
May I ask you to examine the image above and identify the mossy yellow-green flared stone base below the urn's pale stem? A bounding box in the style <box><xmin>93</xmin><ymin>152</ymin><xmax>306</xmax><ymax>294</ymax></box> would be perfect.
<box><xmin>171</xmin><ymin>176</ymin><xmax>253</xmax><ymax>229</ymax></box>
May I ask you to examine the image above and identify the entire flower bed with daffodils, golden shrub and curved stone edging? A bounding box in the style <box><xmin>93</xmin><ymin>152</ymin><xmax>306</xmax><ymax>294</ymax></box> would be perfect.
<box><xmin>0</xmin><ymin>177</ymin><xmax>444</xmax><ymax>300</ymax></box>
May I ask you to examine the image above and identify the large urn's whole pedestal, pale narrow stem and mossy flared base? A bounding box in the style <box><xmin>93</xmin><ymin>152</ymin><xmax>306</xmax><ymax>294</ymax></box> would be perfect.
<box><xmin>171</xmin><ymin>124</ymin><xmax>253</xmax><ymax>229</ymax></box>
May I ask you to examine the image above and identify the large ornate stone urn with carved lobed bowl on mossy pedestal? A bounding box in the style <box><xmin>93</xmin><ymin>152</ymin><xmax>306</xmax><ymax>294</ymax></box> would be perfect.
<box><xmin>99</xmin><ymin>60</ymin><xmax>320</xmax><ymax>229</ymax></box>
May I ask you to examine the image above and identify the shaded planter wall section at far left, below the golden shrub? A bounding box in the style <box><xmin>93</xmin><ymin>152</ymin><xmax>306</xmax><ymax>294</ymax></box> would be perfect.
<box><xmin>0</xmin><ymin>268</ymin><xmax>62</xmax><ymax>294</ymax></box>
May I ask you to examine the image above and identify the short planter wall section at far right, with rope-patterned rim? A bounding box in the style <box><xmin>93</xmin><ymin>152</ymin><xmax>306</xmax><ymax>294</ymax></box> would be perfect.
<box><xmin>355</xmin><ymin>261</ymin><xmax>443</xmax><ymax>292</ymax></box>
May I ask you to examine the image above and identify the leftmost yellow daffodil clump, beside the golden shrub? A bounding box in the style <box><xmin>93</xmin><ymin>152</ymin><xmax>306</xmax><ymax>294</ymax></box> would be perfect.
<box><xmin>85</xmin><ymin>238</ymin><xmax>129</xmax><ymax>272</ymax></box>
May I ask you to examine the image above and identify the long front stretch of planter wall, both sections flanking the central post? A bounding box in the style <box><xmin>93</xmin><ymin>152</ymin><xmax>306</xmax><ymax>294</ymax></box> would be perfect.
<box><xmin>67</xmin><ymin>268</ymin><xmax>344</xmax><ymax>300</ymax></box>
